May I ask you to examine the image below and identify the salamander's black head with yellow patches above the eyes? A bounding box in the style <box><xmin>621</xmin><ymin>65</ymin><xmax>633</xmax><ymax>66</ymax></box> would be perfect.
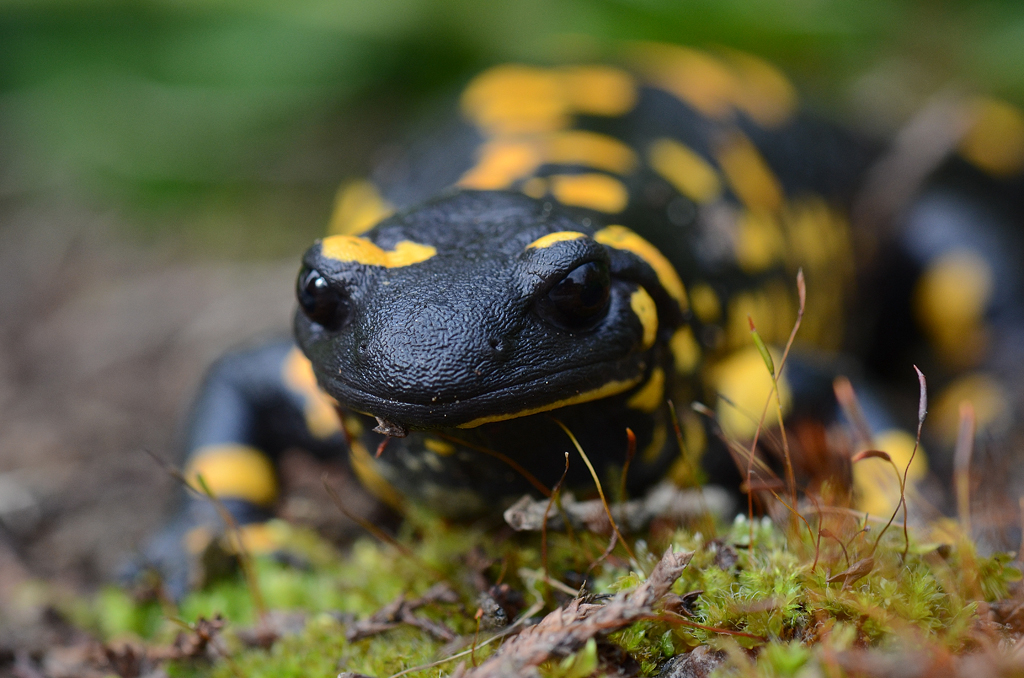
<box><xmin>295</xmin><ymin>192</ymin><xmax>683</xmax><ymax>430</ymax></box>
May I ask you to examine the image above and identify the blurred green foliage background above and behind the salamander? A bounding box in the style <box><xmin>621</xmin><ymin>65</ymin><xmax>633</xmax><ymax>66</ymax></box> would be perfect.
<box><xmin>0</xmin><ymin>0</ymin><xmax>1024</xmax><ymax>257</ymax></box>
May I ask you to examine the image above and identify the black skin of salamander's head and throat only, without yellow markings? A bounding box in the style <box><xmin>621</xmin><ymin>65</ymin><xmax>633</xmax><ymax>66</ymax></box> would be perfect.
<box><xmin>295</xmin><ymin>192</ymin><xmax>685</xmax><ymax>516</ymax></box>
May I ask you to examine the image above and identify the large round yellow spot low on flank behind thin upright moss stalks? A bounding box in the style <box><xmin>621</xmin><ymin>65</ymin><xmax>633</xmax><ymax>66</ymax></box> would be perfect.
<box><xmin>710</xmin><ymin>350</ymin><xmax>793</xmax><ymax>440</ymax></box>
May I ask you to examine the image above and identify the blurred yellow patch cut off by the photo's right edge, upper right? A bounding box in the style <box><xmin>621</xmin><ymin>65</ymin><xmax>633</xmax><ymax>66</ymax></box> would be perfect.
<box><xmin>959</xmin><ymin>98</ymin><xmax>1024</xmax><ymax>176</ymax></box>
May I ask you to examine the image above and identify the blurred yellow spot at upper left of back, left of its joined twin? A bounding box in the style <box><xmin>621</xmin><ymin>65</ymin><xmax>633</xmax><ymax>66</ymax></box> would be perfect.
<box><xmin>462</xmin><ymin>65</ymin><xmax>570</xmax><ymax>135</ymax></box>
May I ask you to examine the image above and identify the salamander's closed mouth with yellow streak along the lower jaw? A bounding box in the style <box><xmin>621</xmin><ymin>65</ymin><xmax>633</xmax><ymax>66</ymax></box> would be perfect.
<box><xmin>318</xmin><ymin>355</ymin><xmax>647</xmax><ymax>429</ymax></box>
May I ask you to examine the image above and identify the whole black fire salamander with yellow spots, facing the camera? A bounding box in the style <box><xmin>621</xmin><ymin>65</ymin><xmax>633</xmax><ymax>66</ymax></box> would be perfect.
<box><xmin>142</xmin><ymin>45</ymin><xmax>1024</xmax><ymax>594</ymax></box>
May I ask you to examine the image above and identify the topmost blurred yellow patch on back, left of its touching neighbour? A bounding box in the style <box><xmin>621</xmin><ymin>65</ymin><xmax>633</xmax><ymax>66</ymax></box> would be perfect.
<box><xmin>637</xmin><ymin>43</ymin><xmax>740</xmax><ymax>119</ymax></box>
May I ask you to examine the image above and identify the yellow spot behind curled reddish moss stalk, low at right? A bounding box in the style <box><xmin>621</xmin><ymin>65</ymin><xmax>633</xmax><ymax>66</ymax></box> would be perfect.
<box><xmin>853</xmin><ymin>429</ymin><xmax>928</xmax><ymax>516</ymax></box>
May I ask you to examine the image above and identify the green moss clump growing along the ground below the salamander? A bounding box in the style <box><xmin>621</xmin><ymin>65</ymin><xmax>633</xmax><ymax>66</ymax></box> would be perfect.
<box><xmin>68</xmin><ymin>501</ymin><xmax>1020</xmax><ymax>678</ymax></box>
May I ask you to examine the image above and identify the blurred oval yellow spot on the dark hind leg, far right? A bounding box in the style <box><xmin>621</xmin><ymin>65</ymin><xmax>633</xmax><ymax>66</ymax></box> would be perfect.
<box><xmin>914</xmin><ymin>249</ymin><xmax>995</xmax><ymax>367</ymax></box>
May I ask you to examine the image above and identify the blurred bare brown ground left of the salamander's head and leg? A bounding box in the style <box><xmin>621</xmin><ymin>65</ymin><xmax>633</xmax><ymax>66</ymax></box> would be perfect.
<box><xmin>0</xmin><ymin>199</ymin><xmax>366</xmax><ymax>599</ymax></box>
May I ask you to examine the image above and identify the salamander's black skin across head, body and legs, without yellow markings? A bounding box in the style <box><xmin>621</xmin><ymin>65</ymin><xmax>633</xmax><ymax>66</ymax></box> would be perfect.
<box><xmin>130</xmin><ymin>62</ymin><xmax>1024</xmax><ymax>597</ymax></box>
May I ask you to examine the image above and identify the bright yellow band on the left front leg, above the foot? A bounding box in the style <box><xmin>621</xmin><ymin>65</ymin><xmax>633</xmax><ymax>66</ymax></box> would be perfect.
<box><xmin>184</xmin><ymin>442</ymin><xmax>278</xmax><ymax>506</ymax></box>
